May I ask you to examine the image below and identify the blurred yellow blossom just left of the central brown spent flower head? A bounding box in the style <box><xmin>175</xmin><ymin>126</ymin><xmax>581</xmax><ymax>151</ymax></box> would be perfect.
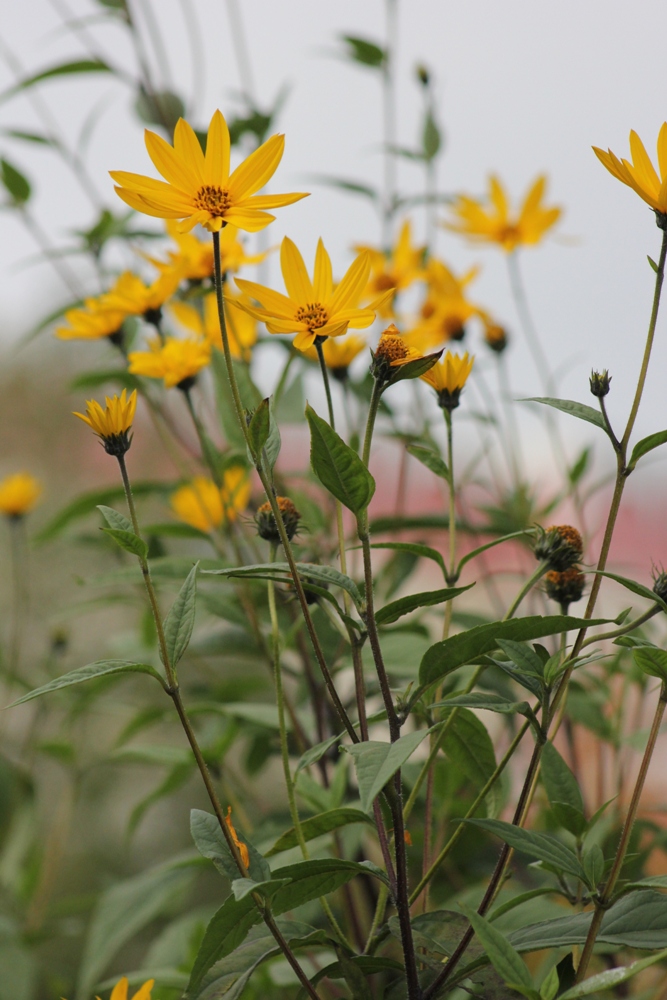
<box><xmin>171</xmin><ymin>465</ymin><xmax>251</xmax><ymax>534</ymax></box>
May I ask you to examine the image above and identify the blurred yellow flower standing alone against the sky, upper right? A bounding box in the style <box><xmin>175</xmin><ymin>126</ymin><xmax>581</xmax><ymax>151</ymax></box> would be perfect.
<box><xmin>445</xmin><ymin>176</ymin><xmax>561</xmax><ymax>253</ymax></box>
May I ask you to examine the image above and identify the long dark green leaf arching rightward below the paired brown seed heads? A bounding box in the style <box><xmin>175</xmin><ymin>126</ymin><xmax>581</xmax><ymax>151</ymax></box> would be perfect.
<box><xmin>419</xmin><ymin>615</ymin><xmax>613</xmax><ymax>686</ymax></box>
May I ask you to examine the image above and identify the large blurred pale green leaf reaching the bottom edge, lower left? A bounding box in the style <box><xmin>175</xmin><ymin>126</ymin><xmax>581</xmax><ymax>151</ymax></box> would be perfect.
<box><xmin>76</xmin><ymin>862</ymin><xmax>197</xmax><ymax>1000</ymax></box>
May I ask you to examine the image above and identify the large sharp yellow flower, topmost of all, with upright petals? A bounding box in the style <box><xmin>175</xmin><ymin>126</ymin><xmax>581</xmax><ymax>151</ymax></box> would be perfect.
<box><xmin>111</xmin><ymin>111</ymin><xmax>306</xmax><ymax>233</ymax></box>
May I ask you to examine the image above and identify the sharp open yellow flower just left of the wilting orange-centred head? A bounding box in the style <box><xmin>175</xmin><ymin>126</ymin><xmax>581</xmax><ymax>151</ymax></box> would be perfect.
<box><xmin>234</xmin><ymin>236</ymin><xmax>391</xmax><ymax>351</ymax></box>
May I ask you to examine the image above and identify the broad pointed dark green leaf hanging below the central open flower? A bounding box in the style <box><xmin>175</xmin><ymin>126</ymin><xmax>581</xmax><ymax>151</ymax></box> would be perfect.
<box><xmin>306</xmin><ymin>406</ymin><xmax>375</xmax><ymax>514</ymax></box>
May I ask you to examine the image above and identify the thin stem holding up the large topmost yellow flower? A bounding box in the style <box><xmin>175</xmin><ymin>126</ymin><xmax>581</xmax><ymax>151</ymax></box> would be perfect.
<box><xmin>211</xmin><ymin>233</ymin><xmax>359</xmax><ymax>743</ymax></box>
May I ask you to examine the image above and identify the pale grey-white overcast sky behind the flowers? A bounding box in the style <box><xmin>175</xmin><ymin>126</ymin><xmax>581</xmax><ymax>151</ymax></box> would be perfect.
<box><xmin>0</xmin><ymin>0</ymin><xmax>667</xmax><ymax>470</ymax></box>
